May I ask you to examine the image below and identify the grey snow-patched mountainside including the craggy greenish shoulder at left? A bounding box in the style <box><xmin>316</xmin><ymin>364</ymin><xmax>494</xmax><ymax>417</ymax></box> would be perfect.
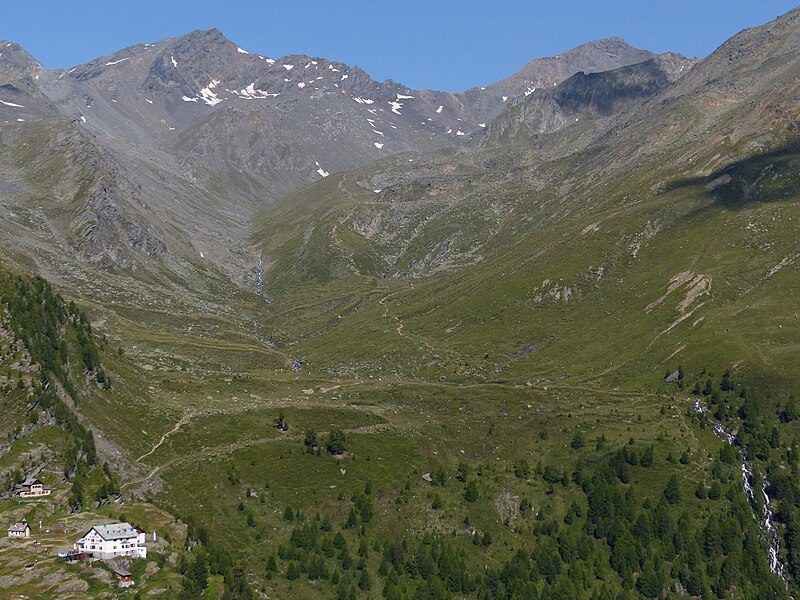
<box><xmin>0</xmin><ymin>29</ymin><xmax>672</xmax><ymax>278</ymax></box>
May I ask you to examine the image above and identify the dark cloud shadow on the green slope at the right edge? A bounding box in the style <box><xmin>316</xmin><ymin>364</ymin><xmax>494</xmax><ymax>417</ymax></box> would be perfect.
<box><xmin>661</xmin><ymin>142</ymin><xmax>800</xmax><ymax>208</ymax></box>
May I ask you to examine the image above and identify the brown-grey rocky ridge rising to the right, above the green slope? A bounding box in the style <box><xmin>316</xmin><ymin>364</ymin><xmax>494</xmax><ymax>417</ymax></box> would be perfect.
<box><xmin>252</xmin><ymin>10</ymin><xmax>800</xmax><ymax>298</ymax></box>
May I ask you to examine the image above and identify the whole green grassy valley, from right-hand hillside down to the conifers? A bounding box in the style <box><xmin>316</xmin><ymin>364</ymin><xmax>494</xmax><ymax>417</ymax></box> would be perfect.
<box><xmin>0</xmin><ymin>122</ymin><xmax>788</xmax><ymax>597</ymax></box>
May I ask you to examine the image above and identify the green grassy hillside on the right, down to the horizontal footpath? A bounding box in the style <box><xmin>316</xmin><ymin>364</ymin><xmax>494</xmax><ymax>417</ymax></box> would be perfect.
<box><xmin>248</xmin><ymin>138</ymin><xmax>800</xmax><ymax>396</ymax></box>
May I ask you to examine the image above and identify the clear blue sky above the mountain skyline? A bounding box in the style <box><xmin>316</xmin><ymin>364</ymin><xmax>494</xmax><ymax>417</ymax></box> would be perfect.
<box><xmin>6</xmin><ymin>0</ymin><xmax>798</xmax><ymax>91</ymax></box>
